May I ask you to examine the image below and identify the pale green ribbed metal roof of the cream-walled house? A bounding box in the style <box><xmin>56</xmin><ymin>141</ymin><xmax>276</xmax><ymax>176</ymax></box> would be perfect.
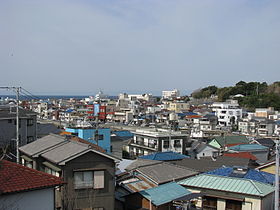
<box><xmin>178</xmin><ymin>174</ymin><xmax>274</xmax><ymax>197</ymax></box>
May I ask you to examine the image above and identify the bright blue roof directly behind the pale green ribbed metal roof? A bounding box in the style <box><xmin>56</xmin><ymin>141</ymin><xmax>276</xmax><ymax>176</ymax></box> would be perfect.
<box><xmin>206</xmin><ymin>167</ymin><xmax>275</xmax><ymax>184</ymax></box>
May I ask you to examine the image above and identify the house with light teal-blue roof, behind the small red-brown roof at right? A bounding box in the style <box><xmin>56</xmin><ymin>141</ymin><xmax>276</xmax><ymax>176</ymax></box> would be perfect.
<box><xmin>228</xmin><ymin>144</ymin><xmax>269</xmax><ymax>163</ymax></box>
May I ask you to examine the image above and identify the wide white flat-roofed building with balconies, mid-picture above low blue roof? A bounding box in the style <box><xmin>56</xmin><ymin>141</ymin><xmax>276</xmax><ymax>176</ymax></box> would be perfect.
<box><xmin>127</xmin><ymin>129</ymin><xmax>188</xmax><ymax>157</ymax></box>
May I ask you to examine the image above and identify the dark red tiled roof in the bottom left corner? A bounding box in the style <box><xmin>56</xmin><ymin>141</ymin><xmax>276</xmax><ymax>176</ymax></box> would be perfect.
<box><xmin>0</xmin><ymin>160</ymin><xmax>64</xmax><ymax>194</ymax></box>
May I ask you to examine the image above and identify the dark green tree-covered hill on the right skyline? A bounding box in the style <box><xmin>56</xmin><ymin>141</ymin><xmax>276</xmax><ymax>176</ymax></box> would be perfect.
<box><xmin>192</xmin><ymin>81</ymin><xmax>280</xmax><ymax>110</ymax></box>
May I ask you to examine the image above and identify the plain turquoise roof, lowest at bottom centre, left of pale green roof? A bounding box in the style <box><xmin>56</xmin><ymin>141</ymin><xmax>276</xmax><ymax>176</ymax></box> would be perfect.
<box><xmin>139</xmin><ymin>182</ymin><xmax>191</xmax><ymax>206</ymax></box>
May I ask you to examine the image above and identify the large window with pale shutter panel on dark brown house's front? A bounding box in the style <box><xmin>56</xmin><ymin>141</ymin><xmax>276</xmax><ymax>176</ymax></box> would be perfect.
<box><xmin>74</xmin><ymin>171</ymin><xmax>104</xmax><ymax>189</ymax></box>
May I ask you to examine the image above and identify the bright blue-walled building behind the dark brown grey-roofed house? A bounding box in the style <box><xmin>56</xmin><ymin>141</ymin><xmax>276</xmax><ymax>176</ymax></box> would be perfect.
<box><xmin>65</xmin><ymin>127</ymin><xmax>111</xmax><ymax>153</ymax></box>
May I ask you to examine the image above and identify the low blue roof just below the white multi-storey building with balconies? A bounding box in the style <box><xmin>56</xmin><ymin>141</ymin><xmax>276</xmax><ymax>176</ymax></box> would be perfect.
<box><xmin>139</xmin><ymin>151</ymin><xmax>188</xmax><ymax>161</ymax></box>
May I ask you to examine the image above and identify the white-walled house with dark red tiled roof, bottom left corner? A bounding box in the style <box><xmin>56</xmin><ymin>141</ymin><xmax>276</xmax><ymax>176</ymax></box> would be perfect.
<box><xmin>0</xmin><ymin>160</ymin><xmax>64</xmax><ymax>210</ymax></box>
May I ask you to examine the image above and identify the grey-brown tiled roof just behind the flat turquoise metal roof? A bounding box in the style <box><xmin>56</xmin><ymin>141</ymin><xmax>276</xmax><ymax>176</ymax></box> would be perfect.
<box><xmin>137</xmin><ymin>163</ymin><xmax>198</xmax><ymax>184</ymax></box>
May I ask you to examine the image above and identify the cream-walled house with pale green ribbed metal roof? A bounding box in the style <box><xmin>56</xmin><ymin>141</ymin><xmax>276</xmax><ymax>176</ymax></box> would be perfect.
<box><xmin>178</xmin><ymin>174</ymin><xmax>274</xmax><ymax>210</ymax></box>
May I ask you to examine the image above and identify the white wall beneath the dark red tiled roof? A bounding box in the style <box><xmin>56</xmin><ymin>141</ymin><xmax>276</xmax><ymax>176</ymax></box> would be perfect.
<box><xmin>0</xmin><ymin>188</ymin><xmax>54</xmax><ymax>210</ymax></box>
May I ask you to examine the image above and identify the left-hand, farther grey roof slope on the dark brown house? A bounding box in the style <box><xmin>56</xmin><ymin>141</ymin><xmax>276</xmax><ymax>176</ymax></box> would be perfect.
<box><xmin>19</xmin><ymin>134</ymin><xmax>67</xmax><ymax>156</ymax></box>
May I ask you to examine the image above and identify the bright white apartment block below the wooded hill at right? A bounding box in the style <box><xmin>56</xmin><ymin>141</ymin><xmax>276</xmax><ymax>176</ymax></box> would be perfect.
<box><xmin>211</xmin><ymin>100</ymin><xmax>242</xmax><ymax>126</ymax></box>
